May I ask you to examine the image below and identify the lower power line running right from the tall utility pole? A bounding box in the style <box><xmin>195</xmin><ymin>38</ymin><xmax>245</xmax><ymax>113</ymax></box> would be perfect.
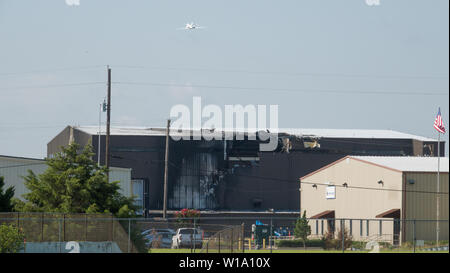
<box><xmin>113</xmin><ymin>82</ymin><xmax>448</xmax><ymax>96</ymax></box>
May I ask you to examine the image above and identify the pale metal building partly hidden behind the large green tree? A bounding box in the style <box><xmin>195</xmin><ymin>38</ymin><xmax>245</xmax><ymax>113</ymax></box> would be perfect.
<box><xmin>0</xmin><ymin>155</ymin><xmax>133</xmax><ymax>200</ymax></box>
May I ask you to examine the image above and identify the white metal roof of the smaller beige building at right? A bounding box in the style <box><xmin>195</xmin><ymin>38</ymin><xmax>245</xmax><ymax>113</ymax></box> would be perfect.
<box><xmin>349</xmin><ymin>156</ymin><xmax>449</xmax><ymax>172</ymax></box>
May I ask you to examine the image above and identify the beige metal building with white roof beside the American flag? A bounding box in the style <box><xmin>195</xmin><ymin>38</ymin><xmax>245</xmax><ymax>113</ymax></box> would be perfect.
<box><xmin>300</xmin><ymin>156</ymin><xmax>449</xmax><ymax>244</ymax></box>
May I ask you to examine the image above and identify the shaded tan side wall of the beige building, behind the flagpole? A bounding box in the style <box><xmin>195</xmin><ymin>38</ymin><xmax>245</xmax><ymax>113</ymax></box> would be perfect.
<box><xmin>405</xmin><ymin>173</ymin><xmax>449</xmax><ymax>241</ymax></box>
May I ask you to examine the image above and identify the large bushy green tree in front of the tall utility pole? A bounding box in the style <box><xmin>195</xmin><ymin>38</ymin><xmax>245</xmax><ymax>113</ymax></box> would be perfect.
<box><xmin>14</xmin><ymin>143</ymin><xmax>135</xmax><ymax>217</ymax></box>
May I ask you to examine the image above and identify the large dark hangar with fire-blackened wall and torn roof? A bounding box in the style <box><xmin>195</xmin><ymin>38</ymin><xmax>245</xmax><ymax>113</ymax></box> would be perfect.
<box><xmin>47</xmin><ymin>126</ymin><xmax>445</xmax><ymax>215</ymax></box>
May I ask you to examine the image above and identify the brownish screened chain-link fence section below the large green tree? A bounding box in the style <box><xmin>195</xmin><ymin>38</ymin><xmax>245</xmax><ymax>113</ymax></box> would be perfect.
<box><xmin>0</xmin><ymin>212</ymin><xmax>138</xmax><ymax>252</ymax></box>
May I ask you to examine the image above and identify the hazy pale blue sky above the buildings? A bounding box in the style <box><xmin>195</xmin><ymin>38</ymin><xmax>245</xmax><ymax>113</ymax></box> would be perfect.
<box><xmin>0</xmin><ymin>0</ymin><xmax>450</xmax><ymax>158</ymax></box>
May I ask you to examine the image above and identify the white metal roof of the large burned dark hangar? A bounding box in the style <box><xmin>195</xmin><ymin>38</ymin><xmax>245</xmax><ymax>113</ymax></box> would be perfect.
<box><xmin>74</xmin><ymin>126</ymin><xmax>436</xmax><ymax>141</ymax></box>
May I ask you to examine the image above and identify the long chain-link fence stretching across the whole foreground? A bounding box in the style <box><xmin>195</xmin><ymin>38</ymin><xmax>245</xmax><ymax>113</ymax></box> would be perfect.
<box><xmin>0</xmin><ymin>213</ymin><xmax>449</xmax><ymax>253</ymax></box>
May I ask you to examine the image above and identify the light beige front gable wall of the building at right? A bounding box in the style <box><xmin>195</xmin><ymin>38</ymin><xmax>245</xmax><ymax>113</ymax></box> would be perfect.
<box><xmin>300</xmin><ymin>158</ymin><xmax>402</xmax><ymax>241</ymax></box>
